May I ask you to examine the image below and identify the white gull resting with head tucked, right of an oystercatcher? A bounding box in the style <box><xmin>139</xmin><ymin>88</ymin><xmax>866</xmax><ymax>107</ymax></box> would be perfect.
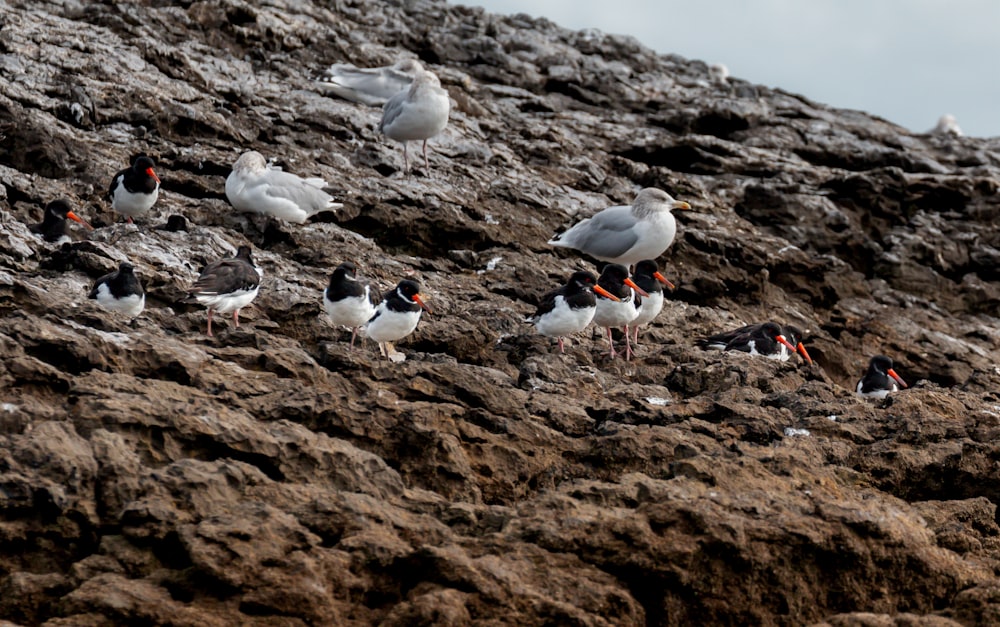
<box><xmin>226</xmin><ymin>150</ymin><xmax>344</xmax><ymax>224</ymax></box>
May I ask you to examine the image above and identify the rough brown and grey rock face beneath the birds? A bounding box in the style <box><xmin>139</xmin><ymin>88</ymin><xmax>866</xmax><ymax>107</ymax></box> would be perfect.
<box><xmin>0</xmin><ymin>0</ymin><xmax>1000</xmax><ymax>626</ymax></box>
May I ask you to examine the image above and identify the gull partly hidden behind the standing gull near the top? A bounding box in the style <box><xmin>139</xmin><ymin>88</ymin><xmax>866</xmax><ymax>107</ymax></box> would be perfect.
<box><xmin>319</xmin><ymin>59</ymin><xmax>424</xmax><ymax>107</ymax></box>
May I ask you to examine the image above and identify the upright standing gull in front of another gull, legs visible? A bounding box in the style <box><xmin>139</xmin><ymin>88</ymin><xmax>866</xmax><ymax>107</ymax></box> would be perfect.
<box><xmin>378</xmin><ymin>70</ymin><xmax>451</xmax><ymax>172</ymax></box>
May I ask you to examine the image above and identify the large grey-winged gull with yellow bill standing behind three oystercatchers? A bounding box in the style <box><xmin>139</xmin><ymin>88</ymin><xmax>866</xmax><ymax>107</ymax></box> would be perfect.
<box><xmin>549</xmin><ymin>187</ymin><xmax>691</xmax><ymax>266</ymax></box>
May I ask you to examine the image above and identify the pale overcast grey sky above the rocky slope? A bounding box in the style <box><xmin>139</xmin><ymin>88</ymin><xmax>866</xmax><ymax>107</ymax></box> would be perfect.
<box><xmin>452</xmin><ymin>0</ymin><xmax>1000</xmax><ymax>137</ymax></box>
